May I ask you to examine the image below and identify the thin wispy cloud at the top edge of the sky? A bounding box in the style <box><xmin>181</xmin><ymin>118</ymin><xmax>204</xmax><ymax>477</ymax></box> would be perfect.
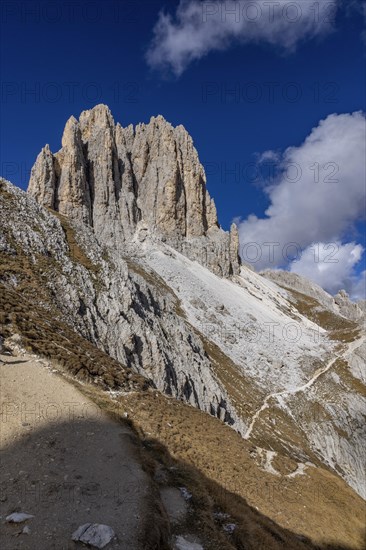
<box><xmin>146</xmin><ymin>0</ymin><xmax>341</xmax><ymax>76</ymax></box>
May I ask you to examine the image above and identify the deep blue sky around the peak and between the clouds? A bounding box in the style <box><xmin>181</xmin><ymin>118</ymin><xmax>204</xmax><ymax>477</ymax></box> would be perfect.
<box><xmin>0</xmin><ymin>0</ymin><xmax>365</xmax><ymax>268</ymax></box>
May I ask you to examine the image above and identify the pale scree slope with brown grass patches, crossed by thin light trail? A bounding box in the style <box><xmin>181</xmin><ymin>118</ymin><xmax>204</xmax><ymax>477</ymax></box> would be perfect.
<box><xmin>135</xmin><ymin>242</ymin><xmax>366</xmax><ymax>497</ymax></box>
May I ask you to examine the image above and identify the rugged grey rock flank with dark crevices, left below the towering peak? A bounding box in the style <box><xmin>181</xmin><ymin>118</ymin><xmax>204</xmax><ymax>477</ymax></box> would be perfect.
<box><xmin>0</xmin><ymin>178</ymin><xmax>243</xmax><ymax>429</ymax></box>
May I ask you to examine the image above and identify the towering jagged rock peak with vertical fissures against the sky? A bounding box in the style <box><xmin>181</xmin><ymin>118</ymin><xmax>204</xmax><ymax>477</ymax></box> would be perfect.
<box><xmin>28</xmin><ymin>105</ymin><xmax>239</xmax><ymax>277</ymax></box>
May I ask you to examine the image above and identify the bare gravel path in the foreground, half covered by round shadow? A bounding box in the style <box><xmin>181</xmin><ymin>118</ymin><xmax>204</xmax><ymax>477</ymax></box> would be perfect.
<box><xmin>0</xmin><ymin>355</ymin><xmax>149</xmax><ymax>550</ymax></box>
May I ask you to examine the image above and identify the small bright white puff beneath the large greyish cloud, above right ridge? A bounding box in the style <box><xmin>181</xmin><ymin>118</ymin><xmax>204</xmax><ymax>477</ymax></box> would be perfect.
<box><xmin>289</xmin><ymin>242</ymin><xmax>364</xmax><ymax>297</ymax></box>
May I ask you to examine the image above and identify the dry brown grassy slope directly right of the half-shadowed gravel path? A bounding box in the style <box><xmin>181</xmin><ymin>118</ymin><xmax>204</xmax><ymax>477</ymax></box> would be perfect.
<box><xmin>78</xmin><ymin>387</ymin><xmax>364</xmax><ymax>550</ymax></box>
